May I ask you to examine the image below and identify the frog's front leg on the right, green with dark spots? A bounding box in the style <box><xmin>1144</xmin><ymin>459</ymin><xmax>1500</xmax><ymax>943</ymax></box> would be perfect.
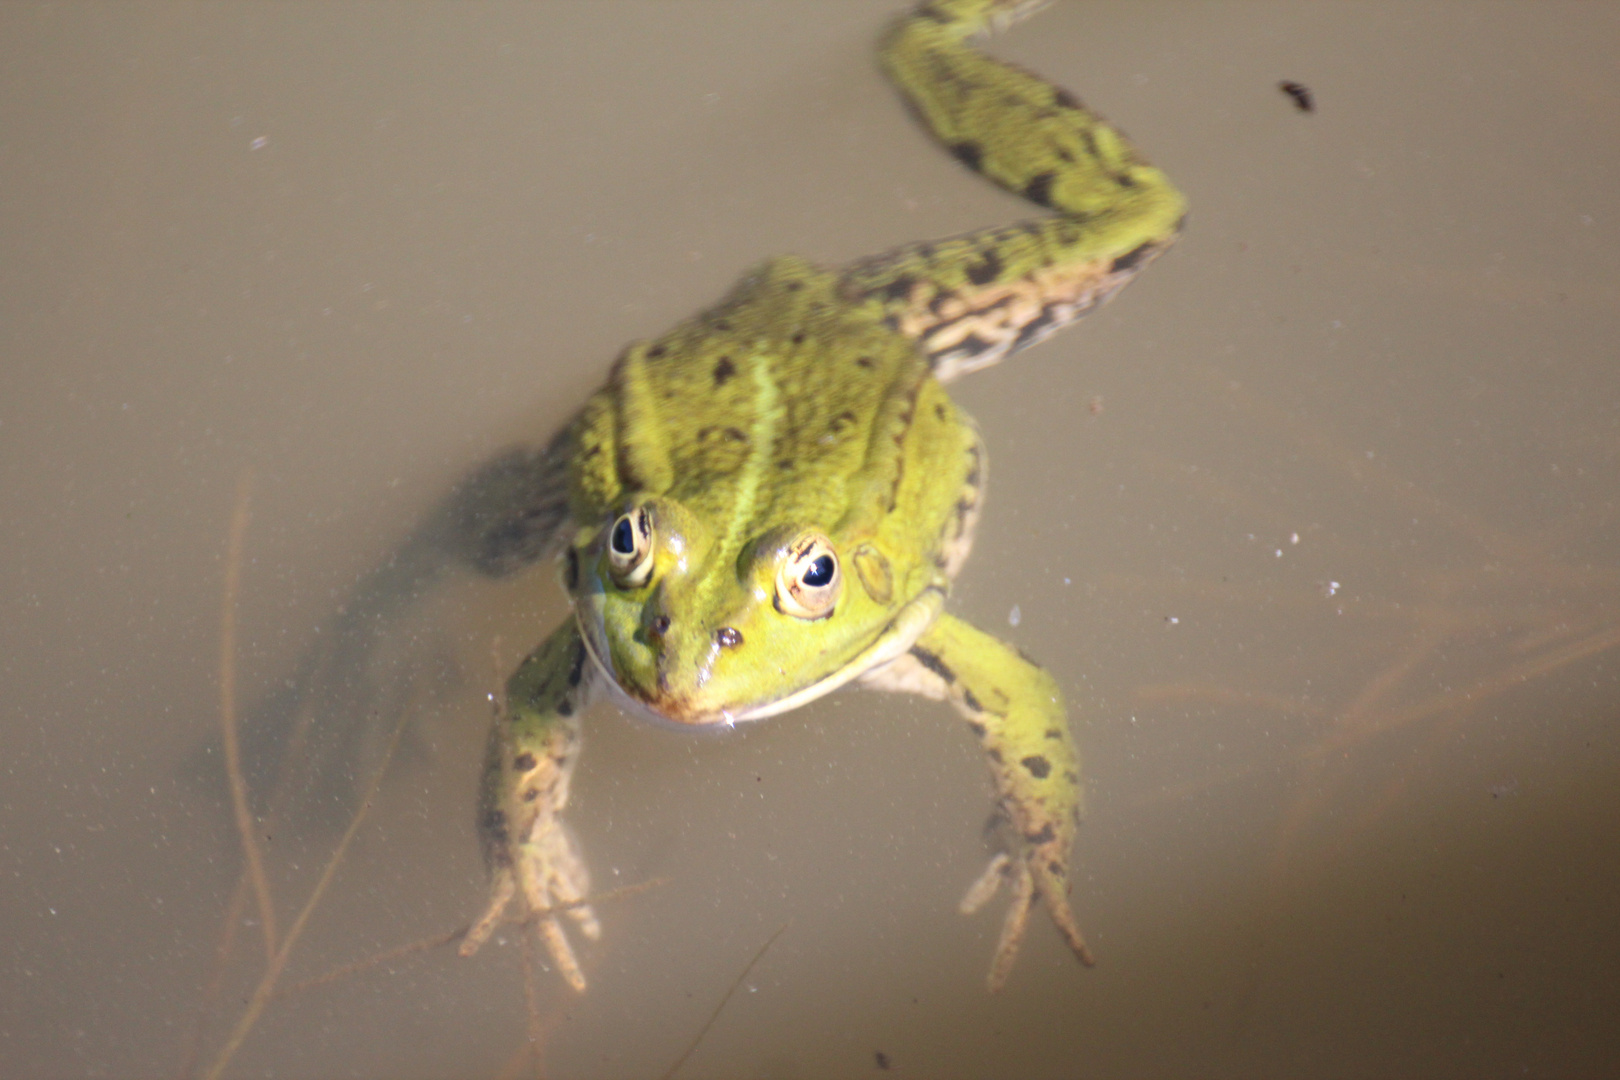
<box><xmin>862</xmin><ymin>615</ymin><xmax>1092</xmax><ymax>991</ymax></box>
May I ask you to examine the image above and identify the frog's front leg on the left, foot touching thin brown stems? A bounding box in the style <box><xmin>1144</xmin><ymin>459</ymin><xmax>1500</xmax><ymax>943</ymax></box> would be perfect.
<box><xmin>462</xmin><ymin>619</ymin><xmax>601</xmax><ymax>991</ymax></box>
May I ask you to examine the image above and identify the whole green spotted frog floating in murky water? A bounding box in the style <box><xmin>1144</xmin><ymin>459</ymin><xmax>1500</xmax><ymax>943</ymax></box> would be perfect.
<box><xmin>460</xmin><ymin>0</ymin><xmax>1186</xmax><ymax>991</ymax></box>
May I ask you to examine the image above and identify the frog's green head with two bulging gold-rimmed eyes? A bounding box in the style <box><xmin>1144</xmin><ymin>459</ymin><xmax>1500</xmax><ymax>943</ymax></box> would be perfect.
<box><xmin>569</xmin><ymin>497</ymin><xmax>943</xmax><ymax>724</ymax></box>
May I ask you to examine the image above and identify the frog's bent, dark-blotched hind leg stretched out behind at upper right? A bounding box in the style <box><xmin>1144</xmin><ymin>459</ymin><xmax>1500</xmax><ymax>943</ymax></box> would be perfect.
<box><xmin>844</xmin><ymin>0</ymin><xmax>1186</xmax><ymax>381</ymax></box>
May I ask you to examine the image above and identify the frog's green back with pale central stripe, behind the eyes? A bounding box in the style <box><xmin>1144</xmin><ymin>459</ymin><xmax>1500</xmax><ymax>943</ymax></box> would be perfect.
<box><xmin>575</xmin><ymin>256</ymin><xmax>977</xmax><ymax>592</ymax></box>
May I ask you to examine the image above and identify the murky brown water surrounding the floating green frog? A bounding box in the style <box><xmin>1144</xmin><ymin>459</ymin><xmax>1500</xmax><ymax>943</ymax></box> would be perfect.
<box><xmin>0</xmin><ymin>0</ymin><xmax>1620</xmax><ymax>1078</ymax></box>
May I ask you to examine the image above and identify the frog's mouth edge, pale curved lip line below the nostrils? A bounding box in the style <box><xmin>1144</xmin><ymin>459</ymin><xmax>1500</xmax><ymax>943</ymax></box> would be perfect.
<box><xmin>575</xmin><ymin>585</ymin><xmax>944</xmax><ymax>727</ymax></box>
